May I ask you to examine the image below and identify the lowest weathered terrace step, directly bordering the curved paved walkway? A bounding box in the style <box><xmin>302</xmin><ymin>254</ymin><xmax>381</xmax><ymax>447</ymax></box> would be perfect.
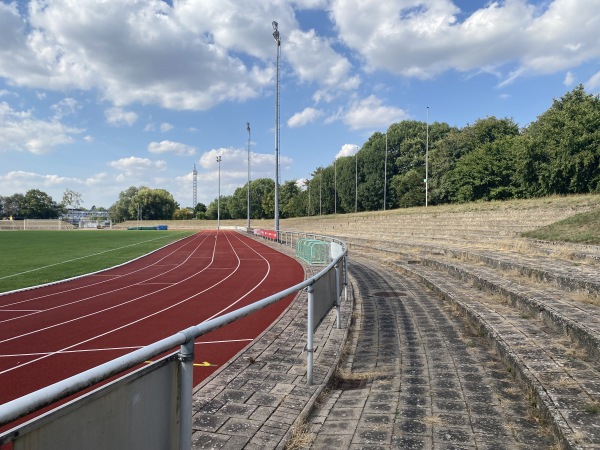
<box><xmin>393</xmin><ymin>255</ymin><xmax>600</xmax><ymax>448</ymax></box>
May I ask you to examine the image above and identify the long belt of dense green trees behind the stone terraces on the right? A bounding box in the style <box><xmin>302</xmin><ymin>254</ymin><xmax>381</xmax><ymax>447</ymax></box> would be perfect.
<box><xmin>207</xmin><ymin>85</ymin><xmax>600</xmax><ymax>219</ymax></box>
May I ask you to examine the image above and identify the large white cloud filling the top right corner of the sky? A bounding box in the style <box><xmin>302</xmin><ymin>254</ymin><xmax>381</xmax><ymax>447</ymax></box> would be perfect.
<box><xmin>331</xmin><ymin>0</ymin><xmax>600</xmax><ymax>83</ymax></box>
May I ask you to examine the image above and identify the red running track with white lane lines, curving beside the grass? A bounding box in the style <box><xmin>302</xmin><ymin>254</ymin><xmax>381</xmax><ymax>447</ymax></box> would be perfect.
<box><xmin>0</xmin><ymin>231</ymin><xmax>304</xmax><ymax>404</ymax></box>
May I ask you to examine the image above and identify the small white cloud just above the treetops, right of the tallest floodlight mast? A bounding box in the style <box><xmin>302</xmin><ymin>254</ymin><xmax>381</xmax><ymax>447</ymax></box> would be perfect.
<box><xmin>343</xmin><ymin>95</ymin><xmax>410</xmax><ymax>130</ymax></box>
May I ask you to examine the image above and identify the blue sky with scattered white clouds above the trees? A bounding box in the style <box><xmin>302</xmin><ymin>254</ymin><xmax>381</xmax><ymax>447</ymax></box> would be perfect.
<box><xmin>0</xmin><ymin>0</ymin><xmax>600</xmax><ymax>209</ymax></box>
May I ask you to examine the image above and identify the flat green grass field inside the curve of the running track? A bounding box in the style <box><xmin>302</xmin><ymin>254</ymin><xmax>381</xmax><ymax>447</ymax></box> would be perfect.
<box><xmin>0</xmin><ymin>230</ymin><xmax>194</xmax><ymax>292</ymax></box>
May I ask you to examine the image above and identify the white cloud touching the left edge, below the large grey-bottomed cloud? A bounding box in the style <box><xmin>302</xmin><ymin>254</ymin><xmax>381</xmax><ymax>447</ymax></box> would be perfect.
<box><xmin>0</xmin><ymin>102</ymin><xmax>83</xmax><ymax>154</ymax></box>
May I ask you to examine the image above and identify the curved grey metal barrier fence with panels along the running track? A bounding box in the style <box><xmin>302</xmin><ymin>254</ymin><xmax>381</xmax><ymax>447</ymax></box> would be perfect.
<box><xmin>0</xmin><ymin>230</ymin><xmax>348</xmax><ymax>450</ymax></box>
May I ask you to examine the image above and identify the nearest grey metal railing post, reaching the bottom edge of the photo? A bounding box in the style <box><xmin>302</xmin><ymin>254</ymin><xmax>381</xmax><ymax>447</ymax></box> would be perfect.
<box><xmin>179</xmin><ymin>337</ymin><xmax>194</xmax><ymax>450</ymax></box>
